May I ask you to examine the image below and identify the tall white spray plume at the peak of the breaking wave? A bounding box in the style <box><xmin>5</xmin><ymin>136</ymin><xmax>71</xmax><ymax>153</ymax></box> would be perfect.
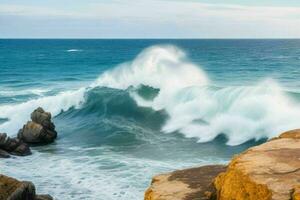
<box><xmin>92</xmin><ymin>46</ymin><xmax>208</xmax><ymax>110</ymax></box>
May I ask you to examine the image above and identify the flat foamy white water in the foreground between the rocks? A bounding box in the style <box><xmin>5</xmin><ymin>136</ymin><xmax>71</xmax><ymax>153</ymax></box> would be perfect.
<box><xmin>1</xmin><ymin>146</ymin><xmax>222</xmax><ymax>200</ymax></box>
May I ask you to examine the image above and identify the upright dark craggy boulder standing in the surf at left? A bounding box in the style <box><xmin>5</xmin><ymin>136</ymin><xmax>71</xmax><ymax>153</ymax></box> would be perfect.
<box><xmin>18</xmin><ymin>107</ymin><xmax>57</xmax><ymax>144</ymax></box>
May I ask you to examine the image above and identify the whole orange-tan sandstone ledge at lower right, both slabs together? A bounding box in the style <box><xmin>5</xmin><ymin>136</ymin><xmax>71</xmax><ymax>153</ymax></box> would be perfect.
<box><xmin>145</xmin><ymin>129</ymin><xmax>300</xmax><ymax>200</ymax></box>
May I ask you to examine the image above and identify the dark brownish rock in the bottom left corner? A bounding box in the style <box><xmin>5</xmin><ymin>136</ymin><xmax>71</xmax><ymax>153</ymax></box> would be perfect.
<box><xmin>0</xmin><ymin>175</ymin><xmax>53</xmax><ymax>200</ymax></box>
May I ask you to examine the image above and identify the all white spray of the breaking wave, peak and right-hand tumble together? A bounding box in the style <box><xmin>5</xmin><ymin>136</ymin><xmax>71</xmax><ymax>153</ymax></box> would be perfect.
<box><xmin>94</xmin><ymin>46</ymin><xmax>300</xmax><ymax>145</ymax></box>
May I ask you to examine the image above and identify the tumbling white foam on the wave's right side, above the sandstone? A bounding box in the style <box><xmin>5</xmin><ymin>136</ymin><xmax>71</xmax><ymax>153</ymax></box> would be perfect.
<box><xmin>163</xmin><ymin>81</ymin><xmax>300</xmax><ymax>145</ymax></box>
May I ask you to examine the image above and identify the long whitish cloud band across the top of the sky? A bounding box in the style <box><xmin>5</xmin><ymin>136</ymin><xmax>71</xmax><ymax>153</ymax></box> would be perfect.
<box><xmin>0</xmin><ymin>0</ymin><xmax>300</xmax><ymax>20</ymax></box>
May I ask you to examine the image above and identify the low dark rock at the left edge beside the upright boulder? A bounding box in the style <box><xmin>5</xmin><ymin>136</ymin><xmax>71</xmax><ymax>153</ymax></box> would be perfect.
<box><xmin>0</xmin><ymin>133</ymin><xmax>31</xmax><ymax>158</ymax></box>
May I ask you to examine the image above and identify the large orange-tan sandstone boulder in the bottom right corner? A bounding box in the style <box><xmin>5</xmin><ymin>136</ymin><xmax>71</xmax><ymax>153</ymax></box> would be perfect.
<box><xmin>214</xmin><ymin>130</ymin><xmax>300</xmax><ymax>200</ymax></box>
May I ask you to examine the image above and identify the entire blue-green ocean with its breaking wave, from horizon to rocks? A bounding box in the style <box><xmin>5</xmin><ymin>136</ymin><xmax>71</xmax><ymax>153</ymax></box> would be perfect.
<box><xmin>0</xmin><ymin>40</ymin><xmax>300</xmax><ymax>200</ymax></box>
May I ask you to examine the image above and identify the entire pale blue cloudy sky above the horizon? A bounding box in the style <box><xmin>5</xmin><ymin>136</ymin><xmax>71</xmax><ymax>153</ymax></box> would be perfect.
<box><xmin>0</xmin><ymin>0</ymin><xmax>300</xmax><ymax>38</ymax></box>
